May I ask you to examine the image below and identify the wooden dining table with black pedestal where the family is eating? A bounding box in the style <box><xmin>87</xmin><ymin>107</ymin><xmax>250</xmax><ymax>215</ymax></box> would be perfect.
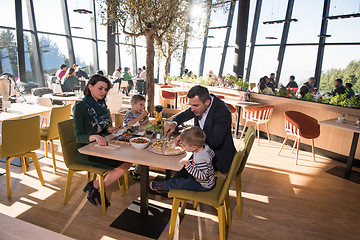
<box><xmin>78</xmin><ymin>135</ymin><xmax>190</xmax><ymax>236</ymax></box>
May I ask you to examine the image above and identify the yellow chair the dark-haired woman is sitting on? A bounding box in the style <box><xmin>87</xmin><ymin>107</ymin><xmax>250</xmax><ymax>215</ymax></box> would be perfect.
<box><xmin>58</xmin><ymin>119</ymin><xmax>128</xmax><ymax>214</ymax></box>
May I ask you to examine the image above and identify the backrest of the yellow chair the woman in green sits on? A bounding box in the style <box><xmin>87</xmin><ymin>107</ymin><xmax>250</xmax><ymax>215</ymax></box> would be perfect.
<box><xmin>58</xmin><ymin>119</ymin><xmax>77</xmax><ymax>167</ymax></box>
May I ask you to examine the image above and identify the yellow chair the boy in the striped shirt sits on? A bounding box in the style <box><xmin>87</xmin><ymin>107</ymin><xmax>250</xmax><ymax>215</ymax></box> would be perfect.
<box><xmin>168</xmin><ymin>140</ymin><xmax>246</xmax><ymax>240</ymax></box>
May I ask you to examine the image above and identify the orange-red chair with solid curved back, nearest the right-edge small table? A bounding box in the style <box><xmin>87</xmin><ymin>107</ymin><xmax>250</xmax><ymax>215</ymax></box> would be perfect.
<box><xmin>278</xmin><ymin>111</ymin><xmax>320</xmax><ymax>165</ymax></box>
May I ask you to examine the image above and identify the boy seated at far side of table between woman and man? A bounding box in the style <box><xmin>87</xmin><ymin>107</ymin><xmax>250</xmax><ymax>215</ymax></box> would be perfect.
<box><xmin>123</xmin><ymin>95</ymin><xmax>149</xmax><ymax>181</ymax></box>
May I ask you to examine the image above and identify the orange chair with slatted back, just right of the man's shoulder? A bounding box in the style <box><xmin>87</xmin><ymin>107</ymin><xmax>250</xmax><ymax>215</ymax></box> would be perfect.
<box><xmin>240</xmin><ymin>105</ymin><xmax>274</xmax><ymax>145</ymax></box>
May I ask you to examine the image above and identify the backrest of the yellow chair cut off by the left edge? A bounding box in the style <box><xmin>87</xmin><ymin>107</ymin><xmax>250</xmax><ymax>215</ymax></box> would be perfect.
<box><xmin>0</xmin><ymin>116</ymin><xmax>40</xmax><ymax>158</ymax></box>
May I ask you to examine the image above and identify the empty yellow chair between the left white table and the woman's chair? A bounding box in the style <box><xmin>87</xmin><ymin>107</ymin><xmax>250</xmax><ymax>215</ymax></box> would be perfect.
<box><xmin>40</xmin><ymin>105</ymin><xmax>71</xmax><ymax>172</ymax></box>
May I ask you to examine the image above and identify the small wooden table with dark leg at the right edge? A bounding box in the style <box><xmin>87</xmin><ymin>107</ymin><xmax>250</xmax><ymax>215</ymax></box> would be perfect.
<box><xmin>319</xmin><ymin>118</ymin><xmax>360</xmax><ymax>178</ymax></box>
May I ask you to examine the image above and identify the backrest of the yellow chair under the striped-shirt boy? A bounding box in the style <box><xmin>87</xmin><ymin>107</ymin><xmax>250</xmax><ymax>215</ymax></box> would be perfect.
<box><xmin>218</xmin><ymin>143</ymin><xmax>246</xmax><ymax>205</ymax></box>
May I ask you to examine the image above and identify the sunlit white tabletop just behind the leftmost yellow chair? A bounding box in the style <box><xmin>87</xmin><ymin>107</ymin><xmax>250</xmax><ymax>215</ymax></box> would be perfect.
<box><xmin>0</xmin><ymin>103</ymin><xmax>52</xmax><ymax>121</ymax></box>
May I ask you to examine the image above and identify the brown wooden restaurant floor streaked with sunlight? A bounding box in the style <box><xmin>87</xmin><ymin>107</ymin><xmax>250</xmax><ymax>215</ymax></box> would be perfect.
<box><xmin>0</xmin><ymin>137</ymin><xmax>360</xmax><ymax>240</ymax></box>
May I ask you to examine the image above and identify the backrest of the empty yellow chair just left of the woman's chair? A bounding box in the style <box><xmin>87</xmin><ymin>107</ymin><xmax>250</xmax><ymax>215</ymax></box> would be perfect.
<box><xmin>47</xmin><ymin>104</ymin><xmax>71</xmax><ymax>139</ymax></box>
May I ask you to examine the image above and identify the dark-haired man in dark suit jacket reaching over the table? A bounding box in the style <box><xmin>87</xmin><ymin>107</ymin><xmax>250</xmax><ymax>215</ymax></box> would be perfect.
<box><xmin>165</xmin><ymin>85</ymin><xmax>236</xmax><ymax>173</ymax></box>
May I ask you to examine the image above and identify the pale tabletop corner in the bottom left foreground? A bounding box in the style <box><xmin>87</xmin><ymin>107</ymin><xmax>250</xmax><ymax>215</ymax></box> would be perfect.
<box><xmin>0</xmin><ymin>213</ymin><xmax>73</xmax><ymax>240</ymax></box>
